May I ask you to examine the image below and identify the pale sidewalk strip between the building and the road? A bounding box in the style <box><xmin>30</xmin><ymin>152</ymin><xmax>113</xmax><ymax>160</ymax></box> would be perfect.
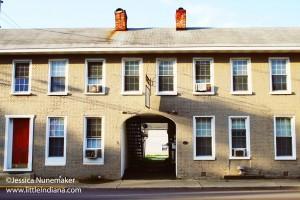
<box><xmin>78</xmin><ymin>179</ymin><xmax>300</xmax><ymax>190</ymax></box>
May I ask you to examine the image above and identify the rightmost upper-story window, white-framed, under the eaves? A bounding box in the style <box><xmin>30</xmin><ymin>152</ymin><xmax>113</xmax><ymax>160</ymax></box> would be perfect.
<box><xmin>269</xmin><ymin>58</ymin><xmax>291</xmax><ymax>94</ymax></box>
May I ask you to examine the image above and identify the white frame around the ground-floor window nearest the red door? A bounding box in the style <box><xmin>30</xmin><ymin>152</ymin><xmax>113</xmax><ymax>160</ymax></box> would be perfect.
<box><xmin>45</xmin><ymin>116</ymin><xmax>67</xmax><ymax>166</ymax></box>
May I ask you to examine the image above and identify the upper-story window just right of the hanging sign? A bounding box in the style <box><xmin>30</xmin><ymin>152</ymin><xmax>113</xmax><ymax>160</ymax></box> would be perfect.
<box><xmin>156</xmin><ymin>59</ymin><xmax>177</xmax><ymax>95</ymax></box>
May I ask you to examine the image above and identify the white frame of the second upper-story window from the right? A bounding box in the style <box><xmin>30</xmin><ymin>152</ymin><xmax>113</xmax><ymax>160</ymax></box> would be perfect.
<box><xmin>230</xmin><ymin>57</ymin><xmax>253</xmax><ymax>95</ymax></box>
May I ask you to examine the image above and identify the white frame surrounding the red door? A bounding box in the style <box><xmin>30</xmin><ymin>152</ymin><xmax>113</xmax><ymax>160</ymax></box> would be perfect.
<box><xmin>3</xmin><ymin>115</ymin><xmax>35</xmax><ymax>172</ymax></box>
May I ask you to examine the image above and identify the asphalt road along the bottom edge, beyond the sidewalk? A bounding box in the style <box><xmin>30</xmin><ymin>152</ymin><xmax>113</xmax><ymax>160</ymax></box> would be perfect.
<box><xmin>0</xmin><ymin>189</ymin><xmax>300</xmax><ymax>200</ymax></box>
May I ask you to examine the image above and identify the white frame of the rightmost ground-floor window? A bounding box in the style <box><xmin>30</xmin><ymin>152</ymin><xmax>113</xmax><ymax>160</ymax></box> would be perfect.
<box><xmin>273</xmin><ymin>115</ymin><xmax>297</xmax><ymax>160</ymax></box>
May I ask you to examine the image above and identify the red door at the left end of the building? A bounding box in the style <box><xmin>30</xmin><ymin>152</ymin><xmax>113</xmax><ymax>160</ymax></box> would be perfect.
<box><xmin>12</xmin><ymin>118</ymin><xmax>30</xmax><ymax>168</ymax></box>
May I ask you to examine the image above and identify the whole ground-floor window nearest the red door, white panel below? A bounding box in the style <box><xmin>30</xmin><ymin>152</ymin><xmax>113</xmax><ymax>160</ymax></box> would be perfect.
<box><xmin>46</xmin><ymin>117</ymin><xmax>66</xmax><ymax>166</ymax></box>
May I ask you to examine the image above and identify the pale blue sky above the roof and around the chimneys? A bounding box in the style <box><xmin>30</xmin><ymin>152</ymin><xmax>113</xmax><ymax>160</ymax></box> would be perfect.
<box><xmin>0</xmin><ymin>0</ymin><xmax>300</xmax><ymax>28</ymax></box>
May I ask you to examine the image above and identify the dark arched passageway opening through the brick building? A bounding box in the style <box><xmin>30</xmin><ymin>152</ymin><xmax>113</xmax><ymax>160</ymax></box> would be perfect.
<box><xmin>121</xmin><ymin>115</ymin><xmax>176</xmax><ymax>179</ymax></box>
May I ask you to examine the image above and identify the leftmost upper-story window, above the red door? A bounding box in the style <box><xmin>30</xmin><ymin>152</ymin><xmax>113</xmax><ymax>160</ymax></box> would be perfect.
<box><xmin>12</xmin><ymin>60</ymin><xmax>31</xmax><ymax>94</ymax></box>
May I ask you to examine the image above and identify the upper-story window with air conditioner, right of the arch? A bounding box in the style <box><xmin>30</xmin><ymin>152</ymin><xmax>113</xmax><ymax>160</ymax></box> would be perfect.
<box><xmin>193</xmin><ymin>58</ymin><xmax>214</xmax><ymax>95</ymax></box>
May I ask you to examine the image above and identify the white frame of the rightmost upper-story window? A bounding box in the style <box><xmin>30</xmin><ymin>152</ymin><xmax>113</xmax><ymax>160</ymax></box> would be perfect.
<box><xmin>269</xmin><ymin>57</ymin><xmax>292</xmax><ymax>95</ymax></box>
